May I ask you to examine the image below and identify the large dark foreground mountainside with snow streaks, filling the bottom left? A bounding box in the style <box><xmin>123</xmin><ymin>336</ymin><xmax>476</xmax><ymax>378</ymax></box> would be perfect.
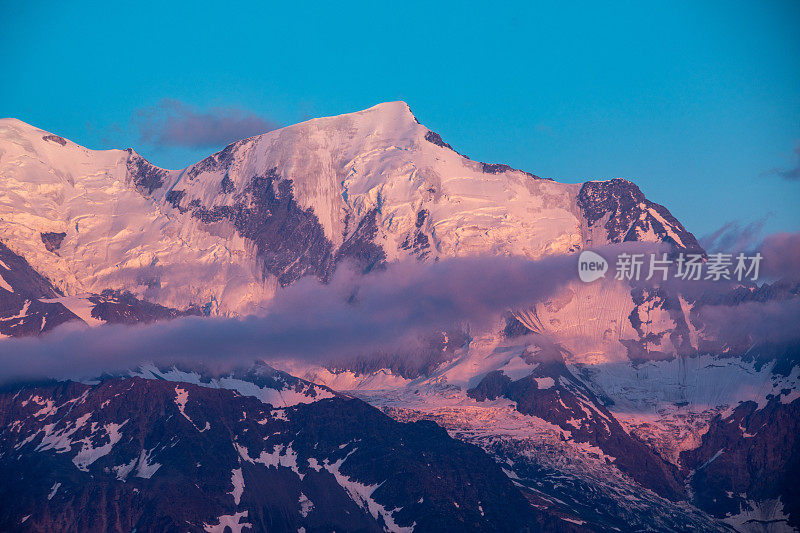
<box><xmin>0</xmin><ymin>378</ymin><xmax>581</xmax><ymax>532</ymax></box>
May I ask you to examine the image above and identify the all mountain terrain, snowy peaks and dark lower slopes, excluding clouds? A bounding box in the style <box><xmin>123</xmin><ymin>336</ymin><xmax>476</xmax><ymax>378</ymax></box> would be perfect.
<box><xmin>0</xmin><ymin>102</ymin><xmax>800</xmax><ymax>532</ymax></box>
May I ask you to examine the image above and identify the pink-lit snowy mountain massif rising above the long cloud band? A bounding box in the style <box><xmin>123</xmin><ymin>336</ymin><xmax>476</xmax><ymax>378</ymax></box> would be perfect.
<box><xmin>0</xmin><ymin>102</ymin><xmax>698</xmax><ymax>314</ymax></box>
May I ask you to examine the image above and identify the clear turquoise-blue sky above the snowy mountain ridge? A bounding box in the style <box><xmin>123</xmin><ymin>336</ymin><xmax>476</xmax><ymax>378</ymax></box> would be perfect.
<box><xmin>0</xmin><ymin>0</ymin><xmax>800</xmax><ymax>235</ymax></box>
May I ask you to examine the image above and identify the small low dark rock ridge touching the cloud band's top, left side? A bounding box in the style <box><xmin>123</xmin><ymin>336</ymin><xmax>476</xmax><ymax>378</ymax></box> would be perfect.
<box><xmin>89</xmin><ymin>289</ymin><xmax>202</xmax><ymax>325</ymax></box>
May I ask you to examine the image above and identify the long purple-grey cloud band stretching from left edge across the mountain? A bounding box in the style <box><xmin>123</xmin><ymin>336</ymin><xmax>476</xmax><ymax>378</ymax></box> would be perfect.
<box><xmin>0</xmin><ymin>256</ymin><xmax>577</xmax><ymax>382</ymax></box>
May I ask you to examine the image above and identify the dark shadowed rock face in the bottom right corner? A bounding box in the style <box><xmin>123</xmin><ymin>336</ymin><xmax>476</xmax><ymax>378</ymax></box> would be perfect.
<box><xmin>680</xmin><ymin>390</ymin><xmax>800</xmax><ymax>530</ymax></box>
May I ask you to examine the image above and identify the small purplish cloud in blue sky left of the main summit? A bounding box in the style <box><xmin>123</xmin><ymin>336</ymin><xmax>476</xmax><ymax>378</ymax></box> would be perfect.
<box><xmin>131</xmin><ymin>98</ymin><xmax>279</xmax><ymax>148</ymax></box>
